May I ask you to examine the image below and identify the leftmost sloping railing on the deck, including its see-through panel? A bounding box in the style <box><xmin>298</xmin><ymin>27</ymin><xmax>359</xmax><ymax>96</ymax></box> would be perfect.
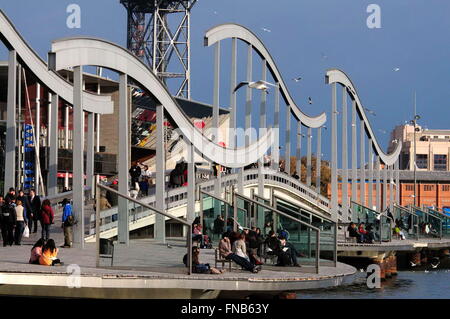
<box><xmin>95</xmin><ymin>184</ymin><xmax>192</xmax><ymax>275</ymax></box>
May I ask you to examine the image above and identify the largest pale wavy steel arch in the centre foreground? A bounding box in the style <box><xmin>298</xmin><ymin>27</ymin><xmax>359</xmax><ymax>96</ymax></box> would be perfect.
<box><xmin>49</xmin><ymin>37</ymin><xmax>275</xmax><ymax>168</ymax></box>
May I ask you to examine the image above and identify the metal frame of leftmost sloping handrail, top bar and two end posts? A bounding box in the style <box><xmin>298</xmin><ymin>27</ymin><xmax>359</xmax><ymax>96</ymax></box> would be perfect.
<box><xmin>95</xmin><ymin>183</ymin><xmax>192</xmax><ymax>275</ymax></box>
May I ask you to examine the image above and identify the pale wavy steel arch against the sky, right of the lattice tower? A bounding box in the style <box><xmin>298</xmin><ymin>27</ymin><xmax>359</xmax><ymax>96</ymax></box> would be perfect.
<box><xmin>205</xmin><ymin>23</ymin><xmax>327</xmax><ymax>128</ymax></box>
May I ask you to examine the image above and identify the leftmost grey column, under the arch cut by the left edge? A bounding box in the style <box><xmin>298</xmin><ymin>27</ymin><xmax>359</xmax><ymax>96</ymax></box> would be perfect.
<box><xmin>4</xmin><ymin>50</ymin><xmax>17</xmax><ymax>194</ymax></box>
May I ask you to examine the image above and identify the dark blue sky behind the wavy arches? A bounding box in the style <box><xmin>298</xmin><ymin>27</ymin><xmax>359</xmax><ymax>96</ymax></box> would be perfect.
<box><xmin>0</xmin><ymin>0</ymin><xmax>450</xmax><ymax>158</ymax></box>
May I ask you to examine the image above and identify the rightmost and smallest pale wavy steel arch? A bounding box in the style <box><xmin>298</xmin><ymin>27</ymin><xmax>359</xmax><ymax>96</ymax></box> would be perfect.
<box><xmin>326</xmin><ymin>69</ymin><xmax>402</xmax><ymax>165</ymax></box>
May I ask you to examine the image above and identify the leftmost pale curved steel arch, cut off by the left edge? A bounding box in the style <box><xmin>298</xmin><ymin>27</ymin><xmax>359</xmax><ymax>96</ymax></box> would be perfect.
<box><xmin>0</xmin><ymin>10</ymin><xmax>114</xmax><ymax>114</ymax></box>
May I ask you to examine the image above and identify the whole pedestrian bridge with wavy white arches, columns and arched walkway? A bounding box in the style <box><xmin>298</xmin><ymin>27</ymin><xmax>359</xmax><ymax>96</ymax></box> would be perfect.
<box><xmin>0</xmin><ymin>7</ymin><xmax>448</xmax><ymax>280</ymax></box>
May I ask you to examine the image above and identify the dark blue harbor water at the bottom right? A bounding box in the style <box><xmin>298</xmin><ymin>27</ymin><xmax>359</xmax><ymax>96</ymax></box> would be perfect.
<box><xmin>297</xmin><ymin>269</ymin><xmax>450</xmax><ymax>299</ymax></box>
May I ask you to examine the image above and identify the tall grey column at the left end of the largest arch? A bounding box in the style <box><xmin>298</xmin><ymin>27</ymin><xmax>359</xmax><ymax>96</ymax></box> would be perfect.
<box><xmin>72</xmin><ymin>66</ymin><xmax>84</xmax><ymax>248</ymax></box>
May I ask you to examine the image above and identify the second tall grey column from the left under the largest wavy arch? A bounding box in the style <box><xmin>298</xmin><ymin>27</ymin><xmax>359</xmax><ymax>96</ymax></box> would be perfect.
<box><xmin>117</xmin><ymin>74</ymin><xmax>129</xmax><ymax>245</ymax></box>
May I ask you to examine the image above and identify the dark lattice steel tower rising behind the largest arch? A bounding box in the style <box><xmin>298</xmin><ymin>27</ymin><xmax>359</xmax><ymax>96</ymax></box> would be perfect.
<box><xmin>120</xmin><ymin>0</ymin><xmax>197</xmax><ymax>99</ymax></box>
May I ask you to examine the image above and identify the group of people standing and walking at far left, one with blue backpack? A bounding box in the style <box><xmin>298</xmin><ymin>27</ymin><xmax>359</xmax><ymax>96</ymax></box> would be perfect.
<box><xmin>0</xmin><ymin>187</ymin><xmax>75</xmax><ymax>247</ymax></box>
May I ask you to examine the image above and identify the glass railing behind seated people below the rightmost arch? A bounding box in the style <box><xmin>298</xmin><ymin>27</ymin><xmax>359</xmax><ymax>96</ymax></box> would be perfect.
<box><xmin>350</xmin><ymin>201</ymin><xmax>394</xmax><ymax>243</ymax></box>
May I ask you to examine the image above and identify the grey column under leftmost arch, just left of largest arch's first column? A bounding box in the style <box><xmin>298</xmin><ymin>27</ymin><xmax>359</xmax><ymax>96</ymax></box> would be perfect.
<box><xmin>47</xmin><ymin>94</ymin><xmax>59</xmax><ymax>195</ymax></box>
